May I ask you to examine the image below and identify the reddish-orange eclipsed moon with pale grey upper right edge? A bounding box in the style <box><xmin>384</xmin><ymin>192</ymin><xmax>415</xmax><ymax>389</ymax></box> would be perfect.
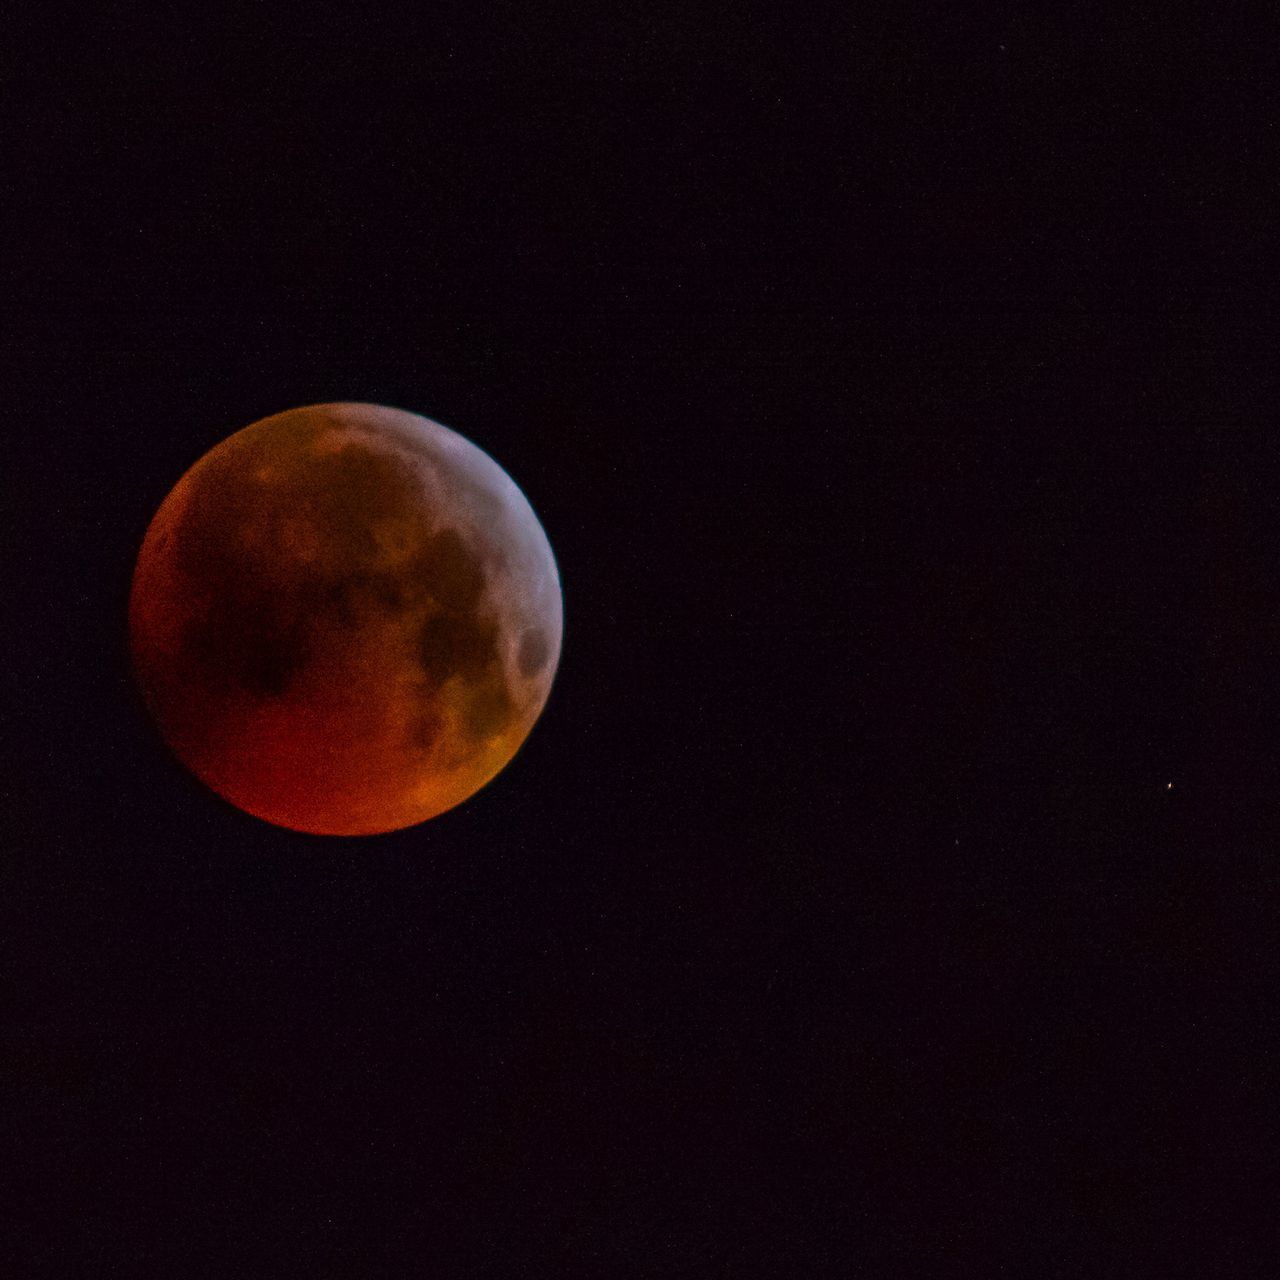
<box><xmin>129</xmin><ymin>403</ymin><xmax>562</xmax><ymax>836</ymax></box>
